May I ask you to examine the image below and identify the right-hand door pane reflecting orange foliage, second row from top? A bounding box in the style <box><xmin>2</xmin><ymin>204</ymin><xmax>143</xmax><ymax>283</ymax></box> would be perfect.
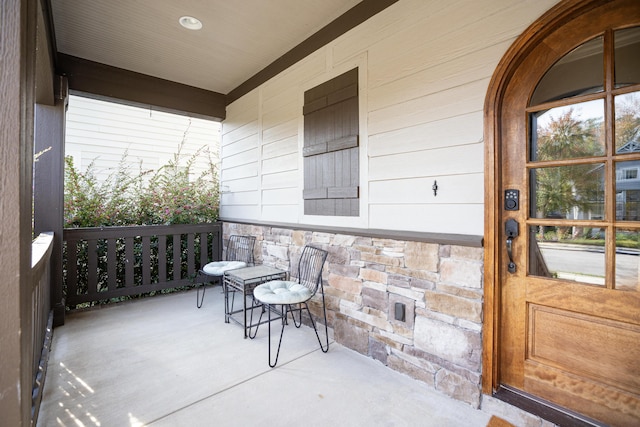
<box><xmin>615</xmin><ymin>92</ymin><xmax>640</xmax><ymax>154</ymax></box>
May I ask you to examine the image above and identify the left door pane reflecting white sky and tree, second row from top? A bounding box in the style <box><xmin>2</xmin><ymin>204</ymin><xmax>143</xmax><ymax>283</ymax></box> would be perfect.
<box><xmin>531</xmin><ymin>99</ymin><xmax>605</xmax><ymax>161</ymax></box>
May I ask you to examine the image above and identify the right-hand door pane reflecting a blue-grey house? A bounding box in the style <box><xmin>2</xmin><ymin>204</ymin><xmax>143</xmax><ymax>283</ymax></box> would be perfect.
<box><xmin>616</xmin><ymin>160</ymin><xmax>640</xmax><ymax>221</ymax></box>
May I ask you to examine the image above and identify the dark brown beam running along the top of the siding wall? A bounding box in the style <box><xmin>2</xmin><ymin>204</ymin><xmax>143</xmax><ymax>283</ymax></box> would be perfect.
<box><xmin>227</xmin><ymin>0</ymin><xmax>398</xmax><ymax>105</ymax></box>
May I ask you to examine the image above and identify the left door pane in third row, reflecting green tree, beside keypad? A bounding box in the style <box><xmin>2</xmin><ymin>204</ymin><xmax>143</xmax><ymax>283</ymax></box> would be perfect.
<box><xmin>530</xmin><ymin>163</ymin><xmax>604</xmax><ymax>219</ymax></box>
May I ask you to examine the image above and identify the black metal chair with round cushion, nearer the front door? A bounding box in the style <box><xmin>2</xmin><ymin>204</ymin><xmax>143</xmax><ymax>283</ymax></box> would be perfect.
<box><xmin>250</xmin><ymin>246</ymin><xmax>329</xmax><ymax>368</ymax></box>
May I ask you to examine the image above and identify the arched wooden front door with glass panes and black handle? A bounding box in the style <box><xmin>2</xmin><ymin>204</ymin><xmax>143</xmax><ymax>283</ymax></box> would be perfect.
<box><xmin>496</xmin><ymin>0</ymin><xmax>640</xmax><ymax>426</ymax></box>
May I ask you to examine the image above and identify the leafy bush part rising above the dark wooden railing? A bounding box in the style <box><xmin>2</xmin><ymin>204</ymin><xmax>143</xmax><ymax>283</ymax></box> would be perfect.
<box><xmin>64</xmin><ymin>140</ymin><xmax>219</xmax><ymax>227</ymax></box>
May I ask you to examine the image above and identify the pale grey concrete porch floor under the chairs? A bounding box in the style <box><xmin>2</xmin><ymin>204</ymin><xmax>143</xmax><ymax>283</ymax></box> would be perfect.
<box><xmin>37</xmin><ymin>287</ymin><xmax>508</xmax><ymax>427</ymax></box>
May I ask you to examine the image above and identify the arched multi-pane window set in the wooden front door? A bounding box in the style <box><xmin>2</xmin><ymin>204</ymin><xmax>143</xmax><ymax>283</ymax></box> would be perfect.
<box><xmin>527</xmin><ymin>27</ymin><xmax>640</xmax><ymax>291</ymax></box>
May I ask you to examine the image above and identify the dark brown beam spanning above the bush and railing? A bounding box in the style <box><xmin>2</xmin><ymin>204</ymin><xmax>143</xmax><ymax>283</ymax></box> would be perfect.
<box><xmin>56</xmin><ymin>53</ymin><xmax>225</xmax><ymax>120</ymax></box>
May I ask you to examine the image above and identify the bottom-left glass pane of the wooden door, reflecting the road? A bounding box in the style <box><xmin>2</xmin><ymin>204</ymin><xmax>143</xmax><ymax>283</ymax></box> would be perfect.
<box><xmin>529</xmin><ymin>225</ymin><xmax>605</xmax><ymax>286</ymax></box>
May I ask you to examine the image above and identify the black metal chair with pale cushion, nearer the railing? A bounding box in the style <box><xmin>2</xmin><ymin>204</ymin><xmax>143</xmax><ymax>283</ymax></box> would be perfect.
<box><xmin>196</xmin><ymin>235</ymin><xmax>256</xmax><ymax>308</ymax></box>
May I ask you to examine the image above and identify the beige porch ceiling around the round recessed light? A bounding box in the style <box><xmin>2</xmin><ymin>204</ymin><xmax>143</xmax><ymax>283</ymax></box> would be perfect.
<box><xmin>50</xmin><ymin>0</ymin><xmax>360</xmax><ymax>94</ymax></box>
